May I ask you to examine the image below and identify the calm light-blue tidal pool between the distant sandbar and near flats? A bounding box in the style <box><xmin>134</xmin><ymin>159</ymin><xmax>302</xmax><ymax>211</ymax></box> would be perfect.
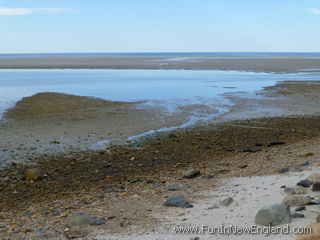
<box><xmin>0</xmin><ymin>70</ymin><xmax>320</xmax><ymax>120</ymax></box>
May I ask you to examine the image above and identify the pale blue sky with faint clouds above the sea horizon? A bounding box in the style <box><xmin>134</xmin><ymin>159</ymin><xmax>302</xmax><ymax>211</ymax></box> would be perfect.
<box><xmin>0</xmin><ymin>0</ymin><xmax>320</xmax><ymax>53</ymax></box>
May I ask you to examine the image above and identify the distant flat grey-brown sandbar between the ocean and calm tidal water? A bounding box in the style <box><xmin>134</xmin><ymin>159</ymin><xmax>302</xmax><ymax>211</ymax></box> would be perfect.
<box><xmin>0</xmin><ymin>57</ymin><xmax>320</xmax><ymax>72</ymax></box>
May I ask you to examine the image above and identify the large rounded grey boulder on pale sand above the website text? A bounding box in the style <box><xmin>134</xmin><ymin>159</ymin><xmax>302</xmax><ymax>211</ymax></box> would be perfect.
<box><xmin>255</xmin><ymin>203</ymin><xmax>291</xmax><ymax>226</ymax></box>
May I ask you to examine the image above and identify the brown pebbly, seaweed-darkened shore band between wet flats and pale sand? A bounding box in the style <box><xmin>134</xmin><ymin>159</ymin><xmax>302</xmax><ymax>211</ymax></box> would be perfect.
<box><xmin>0</xmin><ymin>116</ymin><xmax>320</xmax><ymax>239</ymax></box>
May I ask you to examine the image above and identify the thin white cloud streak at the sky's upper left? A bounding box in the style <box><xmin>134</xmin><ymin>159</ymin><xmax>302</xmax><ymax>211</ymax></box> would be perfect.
<box><xmin>0</xmin><ymin>7</ymin><xmax>71</xmax><ymax>16</ymax></box>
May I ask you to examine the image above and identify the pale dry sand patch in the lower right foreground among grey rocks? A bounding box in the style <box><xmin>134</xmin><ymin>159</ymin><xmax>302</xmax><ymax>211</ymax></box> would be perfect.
<box><xmin>96</xmin><ymin>169</ymin><xmax>319</xmax><ymax>240</ymax></box>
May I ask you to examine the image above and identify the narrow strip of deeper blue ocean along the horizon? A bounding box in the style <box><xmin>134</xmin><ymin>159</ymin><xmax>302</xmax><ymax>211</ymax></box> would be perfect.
<box><xmin>0</xmin><ymin>52</ymin><xmax>320</xmax><ymax>58</ymax></box>
